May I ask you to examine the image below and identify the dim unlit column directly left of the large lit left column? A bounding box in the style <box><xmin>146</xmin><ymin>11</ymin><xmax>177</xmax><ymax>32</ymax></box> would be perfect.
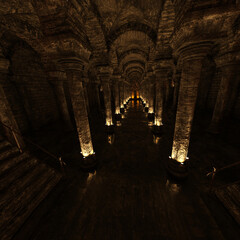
<box><xmin>48</xmin><ymin>71</ymin><xmax>73</xmax><ymax>130</ymax></box>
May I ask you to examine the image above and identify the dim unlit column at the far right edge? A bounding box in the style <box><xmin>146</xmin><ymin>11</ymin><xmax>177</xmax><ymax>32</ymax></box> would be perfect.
<box><xmin>208</xmin><ymin>53</ymin><xmax>240</xmax><ymax>133</ymax></box>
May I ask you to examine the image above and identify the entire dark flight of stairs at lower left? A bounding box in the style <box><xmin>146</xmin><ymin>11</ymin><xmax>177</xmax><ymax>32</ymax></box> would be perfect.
<box><xmin>0</xmin><ymin>140</ymin><xmax>61</xmax><ymax>240</ymax></box>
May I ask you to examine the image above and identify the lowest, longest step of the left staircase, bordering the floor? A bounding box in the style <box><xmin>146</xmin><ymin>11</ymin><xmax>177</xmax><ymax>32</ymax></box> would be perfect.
<box><xmin>0</xmin><ymin>170</ymin><xmax>61</xmax><ymax>240</ymax></box>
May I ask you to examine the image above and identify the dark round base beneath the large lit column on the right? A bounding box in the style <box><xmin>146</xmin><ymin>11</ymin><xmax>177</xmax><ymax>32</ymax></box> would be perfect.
<box><xmin>167</xmin><ymin>158</ymin><xmax>189</xmax><ymax>179</ymax></box>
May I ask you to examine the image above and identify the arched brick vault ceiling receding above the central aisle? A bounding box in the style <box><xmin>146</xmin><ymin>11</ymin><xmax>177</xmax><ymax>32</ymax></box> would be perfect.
<box><xmin>92</xmin><ymin>0</ymin><xmax>164</xmax><ymax>86</ymax></box>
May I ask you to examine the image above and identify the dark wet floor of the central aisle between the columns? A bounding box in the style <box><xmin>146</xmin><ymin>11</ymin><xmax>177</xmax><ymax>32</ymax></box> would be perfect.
<box><xmin>14</xmin><ymin>101</ymin><xmax>240</xmax><ymax>240</ymax></box>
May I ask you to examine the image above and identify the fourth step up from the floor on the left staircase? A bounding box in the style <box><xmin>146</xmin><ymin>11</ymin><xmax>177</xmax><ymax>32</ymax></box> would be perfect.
<box><xmin>0</xmin><ymin>152</ymin><xmax>29</xmax><ymax>176</ymax></box>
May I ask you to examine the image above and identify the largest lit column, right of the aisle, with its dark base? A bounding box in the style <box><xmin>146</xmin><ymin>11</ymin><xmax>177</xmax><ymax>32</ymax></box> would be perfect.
<box><xmin>168</xmin><ymin>42</ymin><xmax>212</xmax><ymax>177</ymax></box>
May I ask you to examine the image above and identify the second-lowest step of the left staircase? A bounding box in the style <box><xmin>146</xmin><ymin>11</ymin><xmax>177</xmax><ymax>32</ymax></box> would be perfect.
<box><xmin>0</xmin><ymin>161</ymin><xmax>46</xmax><ymax>209</ymax></box>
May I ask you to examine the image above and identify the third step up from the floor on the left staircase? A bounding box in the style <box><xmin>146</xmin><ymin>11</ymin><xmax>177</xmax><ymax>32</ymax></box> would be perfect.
<box><xmin>0</xmin><ymin>158</ymin><xmax>37</xmax><ymax>191</ymax></box>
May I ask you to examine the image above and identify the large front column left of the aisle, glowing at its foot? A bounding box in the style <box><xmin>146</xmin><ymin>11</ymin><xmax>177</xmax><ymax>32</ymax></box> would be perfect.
<box><xmin>59</xmin><ymin>58</ymin><xmax>96</xmax><ymax>166</ymax></box>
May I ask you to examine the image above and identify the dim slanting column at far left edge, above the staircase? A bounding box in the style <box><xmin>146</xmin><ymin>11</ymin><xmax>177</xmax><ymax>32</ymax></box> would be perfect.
<box><xmin>0</xmin><ymin>56</ymin><xmax>25</xmax><ymax>151</ymax></box>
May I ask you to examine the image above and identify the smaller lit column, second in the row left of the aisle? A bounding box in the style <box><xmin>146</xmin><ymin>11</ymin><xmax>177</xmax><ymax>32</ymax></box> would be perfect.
<box><xmin>98</xmin><ymin>66</ymin><xmax>113</xmax><ymax>126</ymax></box>
